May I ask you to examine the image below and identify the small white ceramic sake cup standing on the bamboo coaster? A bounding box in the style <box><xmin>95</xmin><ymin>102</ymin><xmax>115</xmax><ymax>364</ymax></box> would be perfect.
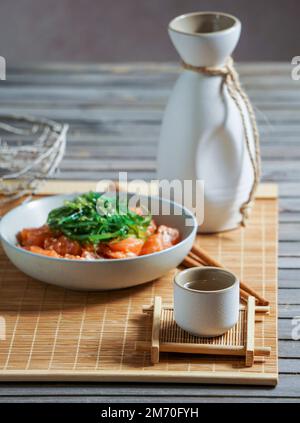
<box><xmin>174</xmin><ymin>267</ymin><xmax>240</xmax><ymax>337</ymax></box>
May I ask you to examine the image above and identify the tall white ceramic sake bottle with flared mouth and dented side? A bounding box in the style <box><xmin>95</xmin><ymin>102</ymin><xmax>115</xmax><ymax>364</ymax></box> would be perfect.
<box><xmin>158</xmin><ymin>12</ymin><xmax>254</xmax><ymax>232</ymax></box>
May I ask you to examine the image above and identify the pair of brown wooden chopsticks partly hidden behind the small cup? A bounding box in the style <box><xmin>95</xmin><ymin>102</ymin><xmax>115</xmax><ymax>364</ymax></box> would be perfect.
<box><xmin>183</xmin><ymin>245</ymin><xmax>269</xmax><ymax>305</ymax></box>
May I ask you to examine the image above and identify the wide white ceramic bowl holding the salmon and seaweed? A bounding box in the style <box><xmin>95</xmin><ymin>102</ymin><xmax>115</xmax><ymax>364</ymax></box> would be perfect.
<box><xmin>0</xmin><ymin>194</ymin><xmax>197</xmax><ymax>290</ymax></box>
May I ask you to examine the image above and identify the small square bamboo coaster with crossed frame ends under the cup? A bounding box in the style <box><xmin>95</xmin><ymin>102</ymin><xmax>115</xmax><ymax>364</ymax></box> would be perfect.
<box><xmin>136</xmin><ymin>296</ymin><xmax>271</xmax><ymax>367</ymax></box>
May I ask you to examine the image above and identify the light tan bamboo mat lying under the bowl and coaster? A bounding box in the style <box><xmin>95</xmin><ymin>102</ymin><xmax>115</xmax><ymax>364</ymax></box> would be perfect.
<box><xmin>0</xmin><ymin>182</ymin><xmax>278</xmax><ymax>385</ymax></box>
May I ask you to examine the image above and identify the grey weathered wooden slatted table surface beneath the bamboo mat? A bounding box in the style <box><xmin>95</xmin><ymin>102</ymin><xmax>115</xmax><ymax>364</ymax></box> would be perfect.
<box><xmin>0</xmin><ymin>63</ymin><xmax>300</xmax><ymax>403</ymax></box>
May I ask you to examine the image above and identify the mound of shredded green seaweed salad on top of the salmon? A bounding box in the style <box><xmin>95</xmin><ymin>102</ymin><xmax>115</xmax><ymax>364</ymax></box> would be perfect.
<box><xmin>47</xmin><ymin>192</ymin><xmax>152</xmax><ymax>245</ymax></box>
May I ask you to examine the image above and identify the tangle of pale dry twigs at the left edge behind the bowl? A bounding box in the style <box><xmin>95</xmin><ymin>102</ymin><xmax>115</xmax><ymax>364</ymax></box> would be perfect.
<box><xmin>0</xmin><ymin>115</ymin><xmax>68</xmax><ymax>202</ymax></box>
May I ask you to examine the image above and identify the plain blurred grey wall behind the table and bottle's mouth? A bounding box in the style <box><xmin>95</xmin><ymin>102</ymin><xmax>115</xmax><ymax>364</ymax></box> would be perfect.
<box><xmin>0</xmin><ymin>0</ymin><xmax>300</xmax><ymax>64</ymax></box>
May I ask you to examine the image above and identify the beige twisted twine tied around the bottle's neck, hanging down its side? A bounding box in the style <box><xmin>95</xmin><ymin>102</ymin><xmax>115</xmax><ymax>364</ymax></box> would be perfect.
<box><xmin>182</xmin><ymin>57</ymin><xmax>261</xmax><ymax>226</ymax></box>
